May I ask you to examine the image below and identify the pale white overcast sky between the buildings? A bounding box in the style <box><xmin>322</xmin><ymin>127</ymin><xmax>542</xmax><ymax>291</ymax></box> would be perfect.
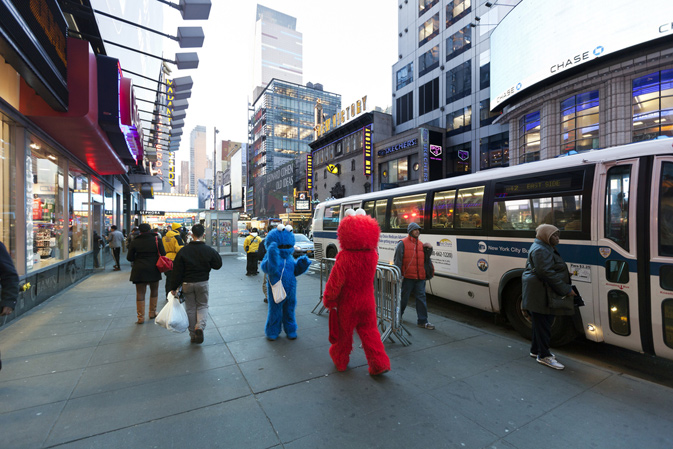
<box><xmin>165</xmin><ymin>0</ymin><xmax>398</xmax><ymax>165</ymax></box>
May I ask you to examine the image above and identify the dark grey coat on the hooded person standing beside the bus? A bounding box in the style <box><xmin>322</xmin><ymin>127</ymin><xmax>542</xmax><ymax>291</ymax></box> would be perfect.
<box><xmin>521</xmin><ymin>239</ymin><xmax>575</xmax><ymax>315</ymax></box>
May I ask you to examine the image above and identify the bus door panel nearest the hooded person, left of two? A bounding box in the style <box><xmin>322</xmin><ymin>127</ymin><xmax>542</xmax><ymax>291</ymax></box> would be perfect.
<box><xmin>596</xmin><ymin>159</ymin><xmax>647</xmax><ymax>352</ymax></box>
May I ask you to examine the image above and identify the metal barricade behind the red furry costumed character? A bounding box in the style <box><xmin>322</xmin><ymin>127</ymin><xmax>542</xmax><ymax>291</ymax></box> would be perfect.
<box><xmin>311</xmin><ymin>258</ymin><xmax>411</xmax><ymax>346</ymax></box>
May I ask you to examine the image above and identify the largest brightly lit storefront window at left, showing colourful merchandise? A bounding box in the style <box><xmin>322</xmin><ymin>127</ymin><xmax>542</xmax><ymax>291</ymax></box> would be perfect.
<box><xmin>26</xmin><ymin>138</ymin><xmax>65</xmax><ymax>271</ymax></box>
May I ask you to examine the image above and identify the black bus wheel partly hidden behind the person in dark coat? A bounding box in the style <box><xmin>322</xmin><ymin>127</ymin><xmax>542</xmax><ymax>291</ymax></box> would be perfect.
<box><xmin>505</xmin><ymin>280</ymin><xmax>577</xmax><ymax>347</ymax></box>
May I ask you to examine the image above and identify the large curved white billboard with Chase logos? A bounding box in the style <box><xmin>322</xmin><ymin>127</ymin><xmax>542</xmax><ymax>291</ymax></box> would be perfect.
<box><xmin>491</xmin><ymin>0</ymin><xmax>673</xmax><ymax>110</ymax></box>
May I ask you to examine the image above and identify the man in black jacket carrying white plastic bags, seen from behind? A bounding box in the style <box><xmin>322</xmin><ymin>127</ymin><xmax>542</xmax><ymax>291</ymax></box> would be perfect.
<box><xmin>171</xmin><ymin>224</ymin><xmax>222</xmax><ymax>343</ymax></box>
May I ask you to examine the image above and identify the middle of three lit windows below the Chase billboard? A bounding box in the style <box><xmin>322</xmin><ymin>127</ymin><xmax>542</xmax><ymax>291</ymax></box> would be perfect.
<box><xmin>561</xmin><ymin>90</ymin><xmax>599</xmax><ymax>154</ymax></box>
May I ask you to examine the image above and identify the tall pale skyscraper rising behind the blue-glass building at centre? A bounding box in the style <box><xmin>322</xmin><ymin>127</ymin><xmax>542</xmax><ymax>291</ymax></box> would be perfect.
<box><xmin>252</xmin><ymin>5</ymin><xmax>303</xmax><ymax>98</ymax></box>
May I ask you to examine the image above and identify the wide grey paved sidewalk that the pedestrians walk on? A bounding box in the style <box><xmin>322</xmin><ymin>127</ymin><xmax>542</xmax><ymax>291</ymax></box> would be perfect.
<box><xmin>0</xmin><ymin>254</ymin><xmax>673</xmax><ymax>449</ymax></box>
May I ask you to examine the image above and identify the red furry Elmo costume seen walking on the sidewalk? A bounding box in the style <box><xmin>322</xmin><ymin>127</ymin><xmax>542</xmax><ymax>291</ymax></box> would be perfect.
<box><xmin>323</xmin><ymin>209</ymin><xmax>390</xmax><ymax>376</ymax></box>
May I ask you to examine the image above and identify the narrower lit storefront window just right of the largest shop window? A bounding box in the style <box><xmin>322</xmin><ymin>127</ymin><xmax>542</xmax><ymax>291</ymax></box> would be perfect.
<box><xmin>68</xmin><ymin>165</ymin><xmax>91</xmax><ymax>257</ymax></box>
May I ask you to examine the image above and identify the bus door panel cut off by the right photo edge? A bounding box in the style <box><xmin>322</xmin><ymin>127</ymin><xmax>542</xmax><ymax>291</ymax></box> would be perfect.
<box><xmin>649</xmin><ymin>156</ymin><xmax>673</xmax><ymax>359</ymax></box>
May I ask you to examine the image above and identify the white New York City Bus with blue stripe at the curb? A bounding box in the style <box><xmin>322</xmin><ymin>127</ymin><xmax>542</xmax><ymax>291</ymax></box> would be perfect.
<box><xmin>313</xmin><ymin>138</ymin><xmax>673</xmax><ymax>359</ymax></box>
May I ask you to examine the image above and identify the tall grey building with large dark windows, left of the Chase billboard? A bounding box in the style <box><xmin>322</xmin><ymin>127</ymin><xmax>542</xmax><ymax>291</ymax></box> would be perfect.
<box><xmin>392</xmin><ymin>0</ymin><xmax>520</xmax><ymax>176</ymax></box>
